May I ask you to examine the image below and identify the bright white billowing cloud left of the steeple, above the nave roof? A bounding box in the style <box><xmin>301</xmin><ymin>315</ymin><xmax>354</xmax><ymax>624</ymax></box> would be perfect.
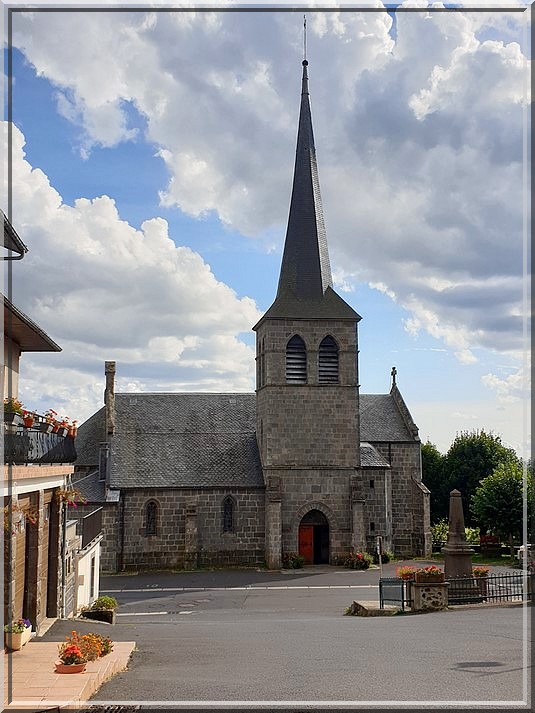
<box><xmin>5</xmin><ymin>128</ymin><xmax>260</xmax><ymax>417</ymax></box>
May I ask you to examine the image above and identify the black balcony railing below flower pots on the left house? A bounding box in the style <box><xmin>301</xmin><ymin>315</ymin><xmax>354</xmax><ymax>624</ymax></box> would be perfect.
<box><xmin>4</xmin><ymin>421</ymin><xmax>76</xmax><ymax>465</ymax></box>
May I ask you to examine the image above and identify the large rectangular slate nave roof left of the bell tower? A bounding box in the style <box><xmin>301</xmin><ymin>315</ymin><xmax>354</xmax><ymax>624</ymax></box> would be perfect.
<box><xmin>110</xmin><ymin>393</ymin><xmax>264</xmax><ymax>488</ymax></box>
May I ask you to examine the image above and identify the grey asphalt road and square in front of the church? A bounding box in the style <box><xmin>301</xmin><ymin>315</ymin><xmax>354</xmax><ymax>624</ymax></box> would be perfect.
<box><xmin>40</xmin><ymin>567</ymin><xmax>530</xmax><ymax>710</ymax></box>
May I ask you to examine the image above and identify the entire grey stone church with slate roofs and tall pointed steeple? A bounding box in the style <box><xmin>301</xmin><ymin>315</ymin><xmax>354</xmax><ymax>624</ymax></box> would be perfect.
<box><xmin>74</xmin><ymin>59</ymin><xmax>431</xmax><ymax>571</ymax></box>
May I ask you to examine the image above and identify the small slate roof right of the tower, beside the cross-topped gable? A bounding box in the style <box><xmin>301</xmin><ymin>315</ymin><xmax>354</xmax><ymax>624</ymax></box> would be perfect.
<box><xmin>359</xmin><ymin>394</ymin><xmax>418</xmax><ymax>443</ymax></box>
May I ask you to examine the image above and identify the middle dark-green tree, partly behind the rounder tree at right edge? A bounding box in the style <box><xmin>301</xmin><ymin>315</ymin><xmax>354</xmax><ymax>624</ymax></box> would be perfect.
<box><xmin>444</xmin><ymin>430</ymin><xmax>520</xmax><ymax>526</ymax></box>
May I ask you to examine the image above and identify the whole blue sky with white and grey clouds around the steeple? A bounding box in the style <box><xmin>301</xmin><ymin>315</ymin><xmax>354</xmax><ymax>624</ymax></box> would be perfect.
<box><xmin>4</xmin><ymin>4</ymin><xmax>527</xmax><ymax>452</ymax></box>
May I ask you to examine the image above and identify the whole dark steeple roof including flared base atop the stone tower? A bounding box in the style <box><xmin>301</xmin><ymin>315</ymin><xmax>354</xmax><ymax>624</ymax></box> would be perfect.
<box><xmin>256</xmin><ymin>60</ymin><xmax>360</xmax><ymax>326</ymax></box>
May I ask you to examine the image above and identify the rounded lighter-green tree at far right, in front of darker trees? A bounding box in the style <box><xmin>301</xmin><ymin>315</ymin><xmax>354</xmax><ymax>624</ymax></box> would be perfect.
<box><xmin>471</xmin><ymin>461</ymin><xmax>533</xmax><ymax>556</ymax></box>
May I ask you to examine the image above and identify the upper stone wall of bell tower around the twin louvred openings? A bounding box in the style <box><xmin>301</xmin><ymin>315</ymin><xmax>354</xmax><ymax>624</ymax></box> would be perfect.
<box><xmin>257</xmin><ymin>319</ymin><xmax>360</xmax><ymax>468</ymax></box>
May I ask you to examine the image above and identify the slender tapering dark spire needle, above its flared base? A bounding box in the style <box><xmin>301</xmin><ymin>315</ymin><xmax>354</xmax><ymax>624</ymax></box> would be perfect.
<box><xmin>277</xmin><ymin>59</ymin><xmax>332</xmax><ymax>300</ymax></box>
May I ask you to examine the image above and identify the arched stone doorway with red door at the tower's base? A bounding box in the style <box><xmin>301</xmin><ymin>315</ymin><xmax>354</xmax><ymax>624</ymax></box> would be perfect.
<box><xmin>293</xmin><ymin>502</ymin><xmax>335</xmax><ymax>564</ymax></box>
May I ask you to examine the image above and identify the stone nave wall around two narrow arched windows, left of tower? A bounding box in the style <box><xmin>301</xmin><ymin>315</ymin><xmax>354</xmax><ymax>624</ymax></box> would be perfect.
<box><xmin>119</xmin><ymin>488</ymin><xmax>265</xmax><ymax>569</ymax></box>
